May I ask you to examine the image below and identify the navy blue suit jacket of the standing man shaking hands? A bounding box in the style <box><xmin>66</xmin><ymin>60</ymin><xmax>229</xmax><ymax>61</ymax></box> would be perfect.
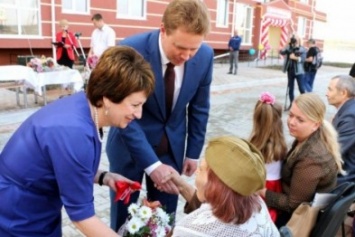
<box><xmin>107</xmin><ymin>30</ymin><xmax>213</xmax><ymax>171</ymax></box>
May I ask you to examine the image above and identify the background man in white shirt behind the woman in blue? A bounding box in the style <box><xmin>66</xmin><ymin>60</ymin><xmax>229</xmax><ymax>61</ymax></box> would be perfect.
<box><xmin>88</xmin><ymin>13</ymin><xmax>116</xmax><ymax>58</ymax></box>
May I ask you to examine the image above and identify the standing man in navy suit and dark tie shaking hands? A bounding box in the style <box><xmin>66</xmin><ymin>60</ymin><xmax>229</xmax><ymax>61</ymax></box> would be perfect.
<box><xmin>106</xmin><ymin>0</ymin><xmax>213</xmax><ymax>230</ymax></box>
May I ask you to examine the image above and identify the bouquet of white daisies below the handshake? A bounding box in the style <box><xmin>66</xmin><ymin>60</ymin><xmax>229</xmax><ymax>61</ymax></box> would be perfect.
<box><xmin>118</xmin><ymin>199</ymin><xmax>173</xmax><ymax>237</ymax></box>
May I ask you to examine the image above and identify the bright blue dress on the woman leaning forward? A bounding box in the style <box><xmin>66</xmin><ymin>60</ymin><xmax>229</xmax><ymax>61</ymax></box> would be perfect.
<box><xmin>0</xmin><ymin>92</ymin><xmax>101</xmax><ymax>237</ymax></box>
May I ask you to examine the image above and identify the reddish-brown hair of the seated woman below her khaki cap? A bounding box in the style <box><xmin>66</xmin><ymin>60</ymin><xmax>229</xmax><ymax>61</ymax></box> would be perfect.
<box><xmin>205</xmin><ymin>169</ymin><xmax>261</xmax><ymax>224</ymax></box>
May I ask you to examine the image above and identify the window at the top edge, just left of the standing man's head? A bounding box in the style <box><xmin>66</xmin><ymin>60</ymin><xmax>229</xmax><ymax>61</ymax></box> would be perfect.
<box><xmin>117</xmin><ymin>0</ymin><xmax>147</xmax><ymax>19</ymax></box>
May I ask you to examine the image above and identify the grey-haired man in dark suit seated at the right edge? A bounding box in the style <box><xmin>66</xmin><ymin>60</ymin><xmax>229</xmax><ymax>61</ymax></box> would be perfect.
<box><xmin>327</xmin><ymin>75</ymin><xmax>355</xmax><ymax>183</ymax></box>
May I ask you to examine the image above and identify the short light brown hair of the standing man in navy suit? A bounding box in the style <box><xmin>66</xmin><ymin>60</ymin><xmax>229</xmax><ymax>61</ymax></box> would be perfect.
<box><xmin>163</xmin><ymin>0</ymin><xmax>210</xmax><ymax>35</ymax></box>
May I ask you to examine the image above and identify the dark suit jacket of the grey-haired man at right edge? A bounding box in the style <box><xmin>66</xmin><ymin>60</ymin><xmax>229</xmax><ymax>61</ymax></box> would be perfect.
<box><xmin>332</xmin><ymin>99</ymin><xmax>355</xmax><ymax>183</ymax></box>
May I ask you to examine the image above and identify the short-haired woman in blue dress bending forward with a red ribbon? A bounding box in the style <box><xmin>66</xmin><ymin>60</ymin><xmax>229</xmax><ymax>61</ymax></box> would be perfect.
<box><xmin>0</xmin><ymin>46</ymin><xmax>154</xmax><ymax>237</ymax></box>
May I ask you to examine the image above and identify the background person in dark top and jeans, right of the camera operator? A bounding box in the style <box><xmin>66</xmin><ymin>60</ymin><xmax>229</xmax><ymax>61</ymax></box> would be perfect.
<box><xmin>304</xmin><ymin>39</ymin><xmax>320</xmax><ymax>92</ymax></box>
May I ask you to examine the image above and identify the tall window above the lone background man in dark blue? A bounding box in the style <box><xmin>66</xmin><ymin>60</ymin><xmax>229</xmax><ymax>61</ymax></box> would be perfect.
<box><xmin>235</xmin><ymin>3</ymin><xmax>253</xmax><ymax>44</ymax></box>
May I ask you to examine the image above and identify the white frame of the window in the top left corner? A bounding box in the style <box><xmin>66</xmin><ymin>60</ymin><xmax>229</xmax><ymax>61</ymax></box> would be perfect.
<box><xmin>0</xmin><ymin>0</ymin><xmax>42</xmax><ymax>39</ymax></box>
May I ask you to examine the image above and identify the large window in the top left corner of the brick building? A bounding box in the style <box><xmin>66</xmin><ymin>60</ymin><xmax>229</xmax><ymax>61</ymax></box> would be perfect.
<box><xmin>0</xmin><ymin>0</ymin><xmax>41</xmax><ymax>36</ymax></box>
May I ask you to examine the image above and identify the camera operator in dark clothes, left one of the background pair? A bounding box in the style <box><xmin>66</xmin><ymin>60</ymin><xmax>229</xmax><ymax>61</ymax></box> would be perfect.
<box><xmin>280</xmin><ymin>35</ymin><xmax>307</xmax><ymax>111</ymax></box>
